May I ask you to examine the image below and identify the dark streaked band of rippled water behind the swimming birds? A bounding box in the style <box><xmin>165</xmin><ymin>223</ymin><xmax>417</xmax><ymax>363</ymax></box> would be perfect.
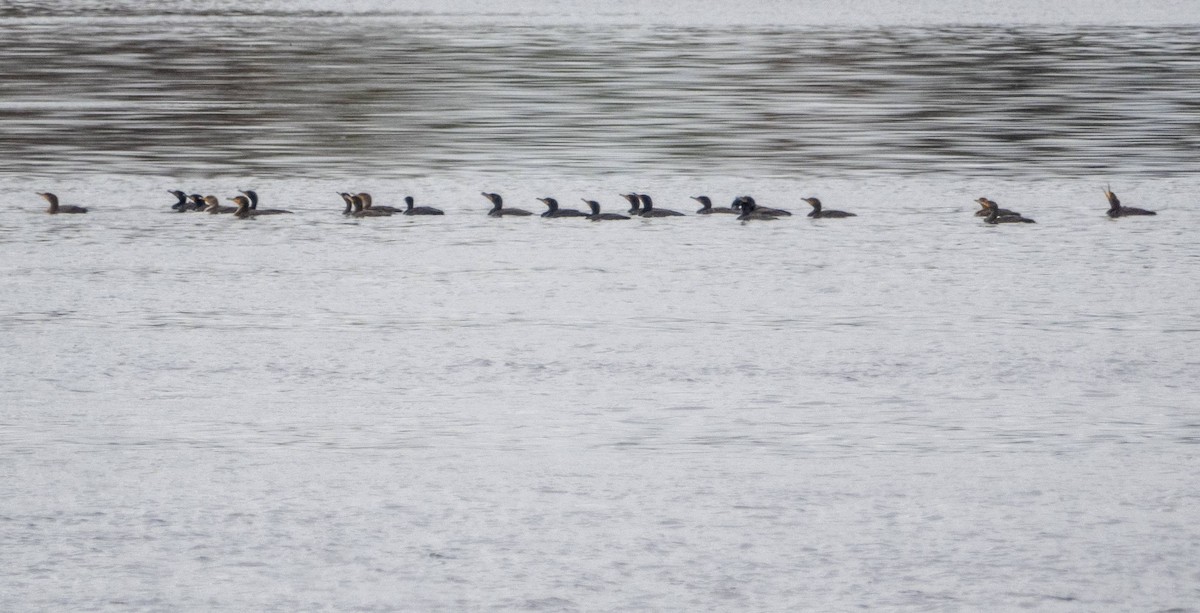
<box><xmin>0</xmin><ymin>2</ymin><xmax>1200</xmax><ymax>176</ymax></box>
